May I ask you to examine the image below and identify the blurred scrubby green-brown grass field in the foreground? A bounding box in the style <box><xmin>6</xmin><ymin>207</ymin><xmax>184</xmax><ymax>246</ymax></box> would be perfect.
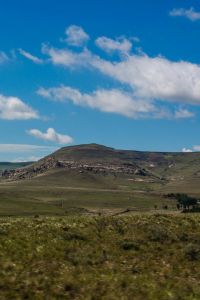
<box><xmin>0</xmin><ymin>214</ymin><xmax>200</xmax><ymax>300</ymax></box>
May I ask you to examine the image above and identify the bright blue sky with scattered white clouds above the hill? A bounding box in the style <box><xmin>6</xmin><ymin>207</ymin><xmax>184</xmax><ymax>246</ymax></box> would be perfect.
<box><xmin>0</xmin><ymin>0</ymin><xmax>200</xmax><ymax>161</ymax></box>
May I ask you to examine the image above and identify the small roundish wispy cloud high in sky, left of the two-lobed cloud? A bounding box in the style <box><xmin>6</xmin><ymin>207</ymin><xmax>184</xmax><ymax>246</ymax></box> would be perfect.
<box><xmin>65</xmin><ymin>25</ymin><xmax>90</xmax><ymax>46</ymax></box>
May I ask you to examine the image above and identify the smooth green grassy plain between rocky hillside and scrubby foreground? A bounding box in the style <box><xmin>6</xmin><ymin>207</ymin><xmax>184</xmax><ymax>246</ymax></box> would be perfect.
<box><xmin>0</xmin><ymin>176</ymin><xmax>173</xmax><ymax>216</ymax></box>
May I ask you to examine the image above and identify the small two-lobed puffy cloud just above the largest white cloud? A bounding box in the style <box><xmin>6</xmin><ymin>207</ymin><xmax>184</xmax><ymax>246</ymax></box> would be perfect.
<box><xmin>95</xmin><ymin>36</ymin><xmax>132</xmax><ymax>53</ymax></box>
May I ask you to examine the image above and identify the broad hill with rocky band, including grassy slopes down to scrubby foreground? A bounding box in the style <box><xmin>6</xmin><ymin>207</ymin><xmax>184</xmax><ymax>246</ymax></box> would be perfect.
<box><xmin>0</xmin><ymin>144</ymin><xmax>200</xmax><ymax>215</ymax></box>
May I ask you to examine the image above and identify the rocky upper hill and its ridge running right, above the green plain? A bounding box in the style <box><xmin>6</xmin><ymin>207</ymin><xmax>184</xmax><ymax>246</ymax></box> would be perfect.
<box><xmin>3</xmin><ymin>144</ymin><xmax>200</xmax><ymax>188</ymax></box>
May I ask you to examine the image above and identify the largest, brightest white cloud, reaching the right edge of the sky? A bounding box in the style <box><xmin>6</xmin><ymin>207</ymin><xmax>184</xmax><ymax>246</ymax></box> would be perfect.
<box><xmin>92</xmin><ymin>54</ymin><xmax>200</xmax><ymax>104</ymax></box>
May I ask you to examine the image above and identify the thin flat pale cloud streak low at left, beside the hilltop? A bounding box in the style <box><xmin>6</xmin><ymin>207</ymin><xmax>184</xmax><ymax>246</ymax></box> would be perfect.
<box><xmin>0</xmin><ymin>144</ymin><xmax>56</xmax><ymax>153</ymax></box>
